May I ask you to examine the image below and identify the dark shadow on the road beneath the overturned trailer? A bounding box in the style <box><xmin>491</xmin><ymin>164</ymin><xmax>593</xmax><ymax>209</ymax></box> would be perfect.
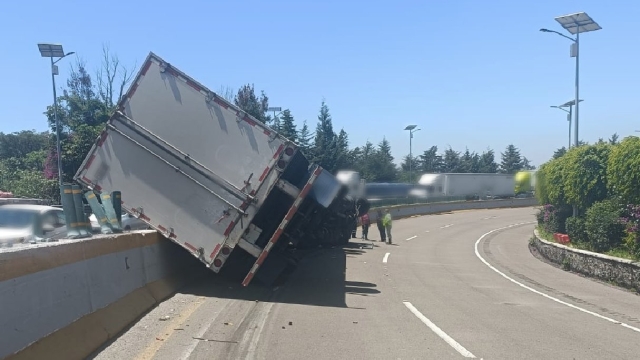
<box><xmin>179</xmin><ymin>241</ymin><xmax>380</xmax><ymax>308</ymax></box>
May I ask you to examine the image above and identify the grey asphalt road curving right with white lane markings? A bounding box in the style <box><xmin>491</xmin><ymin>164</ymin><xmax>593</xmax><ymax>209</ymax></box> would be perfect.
<box><xmin>89</xmin><ymin>208</ymin><xmax>640</xmax><ymax>360</ymax></box>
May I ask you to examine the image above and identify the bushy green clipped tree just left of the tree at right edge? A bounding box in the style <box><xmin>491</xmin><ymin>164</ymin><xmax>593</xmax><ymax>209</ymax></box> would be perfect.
<box><xmin>561</xmin><ymin>143</ymin><xmax>611</xmax><ymax>212</ymax></box>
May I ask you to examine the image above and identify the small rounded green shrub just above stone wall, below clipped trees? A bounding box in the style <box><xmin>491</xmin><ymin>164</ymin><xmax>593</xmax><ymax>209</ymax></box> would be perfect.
<box><xmin>585</xmin><ymin>200</ymin><xmax>624</xmax><ymax>252</ymax></box>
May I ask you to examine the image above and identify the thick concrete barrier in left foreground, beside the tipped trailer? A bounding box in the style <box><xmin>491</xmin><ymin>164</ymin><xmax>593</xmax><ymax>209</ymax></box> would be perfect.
<box><xmin>0</xmin><ymin>231</ymin><xmax>199</xmax><ymax>360</ymax></box>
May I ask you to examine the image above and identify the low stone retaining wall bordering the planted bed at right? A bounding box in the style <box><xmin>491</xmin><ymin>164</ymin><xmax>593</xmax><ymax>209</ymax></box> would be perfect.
<box><xmin>531</xmin><ymin>230</ymin><xmax>640</xmax><ymax>292</ymax></box>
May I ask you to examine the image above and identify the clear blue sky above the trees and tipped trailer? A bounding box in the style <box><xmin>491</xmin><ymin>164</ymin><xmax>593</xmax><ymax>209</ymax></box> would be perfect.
<box><xmin>0</xmin><ymin>0</ymin><xmax>640</xmax><ymax>165</ymax></box>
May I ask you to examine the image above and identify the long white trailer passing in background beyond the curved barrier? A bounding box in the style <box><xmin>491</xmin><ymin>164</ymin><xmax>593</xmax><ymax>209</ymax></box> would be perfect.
<box><xmin>418</xmin><ymin>173</ymin><xmax>515</xmax><ymax>198</ymax></box>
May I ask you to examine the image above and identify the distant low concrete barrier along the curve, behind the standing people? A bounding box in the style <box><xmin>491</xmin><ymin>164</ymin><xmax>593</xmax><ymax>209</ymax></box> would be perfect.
<box><xmin>369</xmin><ymin>198</ymin><xmax>538</xmax><ymax>222</ymax></box>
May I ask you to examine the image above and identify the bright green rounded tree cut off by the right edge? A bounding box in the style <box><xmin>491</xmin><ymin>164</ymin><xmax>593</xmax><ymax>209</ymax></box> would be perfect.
<box><xmin>607</xmin><ymin>136</ymin><xmax>640</xmax><ymax>204</ymax></box>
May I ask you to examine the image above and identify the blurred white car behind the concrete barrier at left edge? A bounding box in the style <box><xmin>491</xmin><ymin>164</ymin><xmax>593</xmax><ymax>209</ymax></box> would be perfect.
<box><xmin>0</xmin><ymin>204</ymin><xmax>67</xmax><ymax>247</ymax></box>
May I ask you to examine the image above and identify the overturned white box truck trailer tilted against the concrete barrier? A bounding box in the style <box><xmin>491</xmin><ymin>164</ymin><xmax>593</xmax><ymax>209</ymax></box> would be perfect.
<box><xmin>75</xmin><ymin>53</ymin><xmax>368</xmax><ymax>286</ymax></box>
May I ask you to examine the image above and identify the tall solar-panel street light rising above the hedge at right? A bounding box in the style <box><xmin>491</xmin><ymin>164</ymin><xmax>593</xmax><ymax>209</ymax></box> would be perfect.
<box><xmin>540</xmin><ymin>12</ymin><xmax>602</xmax><ymax>146</ymax></box>
